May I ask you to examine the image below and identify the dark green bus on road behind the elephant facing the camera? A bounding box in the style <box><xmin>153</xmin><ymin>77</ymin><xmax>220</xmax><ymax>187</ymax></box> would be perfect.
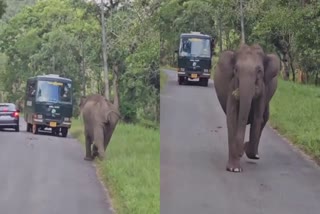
<box><xmin>175</xmin><ymin>32</ymin><xmax>215</xmax><ymax>86</ymax></box>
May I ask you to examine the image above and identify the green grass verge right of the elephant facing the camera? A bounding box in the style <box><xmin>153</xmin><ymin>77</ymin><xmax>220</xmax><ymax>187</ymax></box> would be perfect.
<box><xmin>270</xmin><ymin>79</ymin><xmax>320</xmax><ymax>163</ymax></box>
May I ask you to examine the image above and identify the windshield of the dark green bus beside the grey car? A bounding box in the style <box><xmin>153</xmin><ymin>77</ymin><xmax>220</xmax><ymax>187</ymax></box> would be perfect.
<box><xmin>36</xmin><ymin>80</ymin><xmax>72</xmax><ymax>103</ymax></box>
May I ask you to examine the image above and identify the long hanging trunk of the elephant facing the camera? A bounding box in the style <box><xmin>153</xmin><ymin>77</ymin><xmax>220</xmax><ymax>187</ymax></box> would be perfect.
<box><xmin>236</xmin><ymin>76</ymin><xmax>255</xmax><ymax>143</ymax></box>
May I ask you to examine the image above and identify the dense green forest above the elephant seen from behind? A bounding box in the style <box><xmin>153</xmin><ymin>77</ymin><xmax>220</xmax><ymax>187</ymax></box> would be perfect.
<box><xmin>0</xmin><ymin>0</ymin><xmax>160</xmax><ymax>125</ymax></box>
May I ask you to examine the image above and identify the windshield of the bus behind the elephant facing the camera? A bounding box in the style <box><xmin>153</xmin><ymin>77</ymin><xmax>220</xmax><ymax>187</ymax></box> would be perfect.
<box><xmin>180</xmin><ymin>37</ymin><xmax>211</xmax><ymax>58</ymax></box>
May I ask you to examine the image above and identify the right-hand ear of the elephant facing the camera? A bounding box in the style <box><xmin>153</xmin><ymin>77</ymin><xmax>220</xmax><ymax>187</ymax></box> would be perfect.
<box><xmin>264</xmin><ymin>54</ymin><xmax>281</xmax><ymax>83</ymax></box>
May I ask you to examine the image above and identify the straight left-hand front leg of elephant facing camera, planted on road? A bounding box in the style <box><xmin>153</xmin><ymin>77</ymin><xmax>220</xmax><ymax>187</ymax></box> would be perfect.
<box><xmin>226</xmin><ymin>96</ymin><xmax>242</xmax><ymax>172</ymax></box>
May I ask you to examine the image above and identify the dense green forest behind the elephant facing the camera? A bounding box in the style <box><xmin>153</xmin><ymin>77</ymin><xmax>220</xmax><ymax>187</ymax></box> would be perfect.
<box><xmin>160</xmin><ymin>0</ymin><xmax>320</xmax><ymax>85</ymax></box>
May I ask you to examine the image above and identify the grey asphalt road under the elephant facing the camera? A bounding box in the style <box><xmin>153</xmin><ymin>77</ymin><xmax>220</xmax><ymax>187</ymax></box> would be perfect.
<box><xmin>160</xmin><ymin>71</ymin><xmax>320</xmax><ymax>214</ymax></box>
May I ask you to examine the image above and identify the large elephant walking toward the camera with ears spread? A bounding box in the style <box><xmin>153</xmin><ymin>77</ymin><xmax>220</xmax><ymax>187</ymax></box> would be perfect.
<box><xmin>214</xmin><ymin>44</ymin><xmax>281</xmax><ymax>172</ymax></box>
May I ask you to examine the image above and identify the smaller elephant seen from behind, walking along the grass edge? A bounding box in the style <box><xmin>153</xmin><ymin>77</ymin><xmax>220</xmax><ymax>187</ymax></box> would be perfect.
<box><xmin>80</xmin><ymin>94</ymin><xmax>120</xmax><ymax>161</ymax></box>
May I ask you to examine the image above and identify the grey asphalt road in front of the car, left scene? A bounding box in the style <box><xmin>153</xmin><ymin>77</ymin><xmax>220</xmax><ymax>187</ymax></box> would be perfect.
<box><xmin>0</xmin><ymin>120</ymin><xmax>112</xmax><ymax>214</ymax></box>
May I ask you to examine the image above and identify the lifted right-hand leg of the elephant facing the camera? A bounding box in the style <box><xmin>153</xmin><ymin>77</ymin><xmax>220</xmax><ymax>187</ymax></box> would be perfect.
<box><xmin>245</xmin><ymin>101</ymin><xmax>269</xmax><ymax>160</ymax></box>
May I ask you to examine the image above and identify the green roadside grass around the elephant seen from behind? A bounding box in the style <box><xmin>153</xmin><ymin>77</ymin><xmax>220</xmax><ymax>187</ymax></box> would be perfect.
<box><xmin>71</xmin><ymin>120</ymin><xmax>160</xmax><ymax>214</ymax></box>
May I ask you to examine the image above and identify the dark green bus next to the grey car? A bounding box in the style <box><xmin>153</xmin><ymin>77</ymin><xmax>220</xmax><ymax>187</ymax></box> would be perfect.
<box><xmin>24</xmin><ymin>74</ymin><xmax>73</xmax><ymax>137</ymax></box>
